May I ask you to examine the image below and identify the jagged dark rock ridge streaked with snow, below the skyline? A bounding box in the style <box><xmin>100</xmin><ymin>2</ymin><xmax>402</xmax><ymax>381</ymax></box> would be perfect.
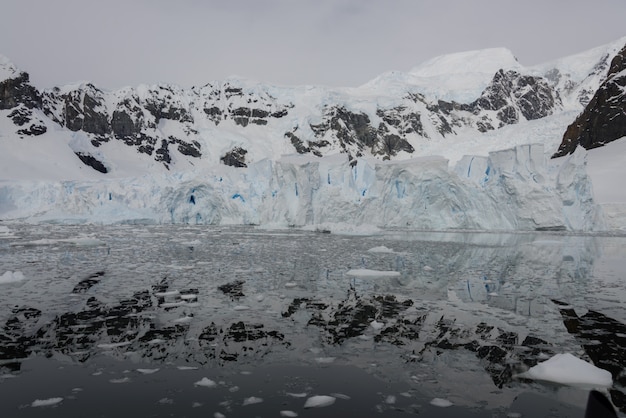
<box><xmin>0</xmin><ymin>37</ymin><xmax>616</xmax><ymax>173</ymax></box>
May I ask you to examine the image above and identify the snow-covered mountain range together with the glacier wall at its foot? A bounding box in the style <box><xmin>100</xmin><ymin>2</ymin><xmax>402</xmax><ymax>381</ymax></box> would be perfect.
<box><xmin>0</xmin><ymin>39</ymin><xmax>626</xmax><ymax>230</ymax></box>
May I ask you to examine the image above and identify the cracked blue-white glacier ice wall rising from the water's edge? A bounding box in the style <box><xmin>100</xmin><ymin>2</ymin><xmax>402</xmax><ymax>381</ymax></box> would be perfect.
<box><xmin>0</xmin><ymin>145</ymin><xmax>603</xmax><ymax>231</ymax></box>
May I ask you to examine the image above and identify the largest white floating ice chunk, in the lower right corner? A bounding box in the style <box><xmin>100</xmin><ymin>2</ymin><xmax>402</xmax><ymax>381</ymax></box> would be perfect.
<box><xmin>517</xmin><ymin>353</ymin><xmax>613</xmax><ymax>387</ymax></box>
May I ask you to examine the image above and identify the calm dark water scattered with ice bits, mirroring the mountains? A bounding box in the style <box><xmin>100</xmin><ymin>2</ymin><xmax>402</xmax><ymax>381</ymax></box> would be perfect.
<box><xmin>0</xmin><ymin>224</ymin><xmax>626</xmax><ymax>417</ymax></box>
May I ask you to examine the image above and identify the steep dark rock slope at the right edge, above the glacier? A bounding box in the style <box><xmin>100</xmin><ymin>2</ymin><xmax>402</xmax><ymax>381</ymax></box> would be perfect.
<box><xmin>554</xmin><ymin>42</ymin><xmax>626</xmax><ymax>157</ymax></box>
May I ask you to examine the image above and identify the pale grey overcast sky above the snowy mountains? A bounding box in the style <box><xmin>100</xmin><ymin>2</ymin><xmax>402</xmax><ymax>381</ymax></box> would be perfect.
<box><xmin>0</xmin><ymin>0</ymin><xmax>626</xmax><ymax>89</ymax></box>
